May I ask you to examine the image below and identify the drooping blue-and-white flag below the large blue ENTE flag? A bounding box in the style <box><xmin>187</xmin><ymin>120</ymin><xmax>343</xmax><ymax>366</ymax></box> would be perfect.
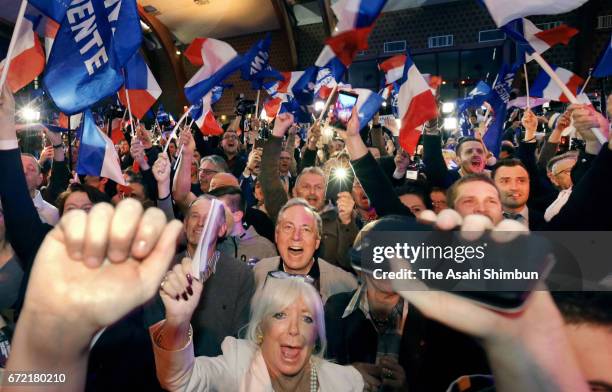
<box><xmin>77</xmin><ymin>109</ymin><xmax>126</xmax><ymax>185</ymax></box>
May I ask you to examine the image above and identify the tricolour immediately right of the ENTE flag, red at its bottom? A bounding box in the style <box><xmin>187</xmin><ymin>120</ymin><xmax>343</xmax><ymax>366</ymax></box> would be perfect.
<box><xmin>119</xmin><ymin>52</ymin><xmax>162</xmax><ymax>119</ymax></box>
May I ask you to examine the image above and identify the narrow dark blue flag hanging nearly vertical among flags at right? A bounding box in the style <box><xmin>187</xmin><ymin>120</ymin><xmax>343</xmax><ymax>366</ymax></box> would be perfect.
<box><xmin>483</xmin><ymin>61</ymin><xmax>522</xmax><ymax>156</ymax></box>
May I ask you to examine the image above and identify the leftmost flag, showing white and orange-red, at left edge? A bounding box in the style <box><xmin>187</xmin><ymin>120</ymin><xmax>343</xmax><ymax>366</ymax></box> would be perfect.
<box><xmin>0</xmin><ymin>17</ymin><xmax>45</xmax><ymax>92</ymax></box>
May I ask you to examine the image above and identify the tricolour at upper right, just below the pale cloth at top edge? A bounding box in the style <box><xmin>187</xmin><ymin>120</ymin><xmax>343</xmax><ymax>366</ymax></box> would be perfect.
<box><xmin>502</xmin><ymin>18</ymin><xmax>578</xmax><ymax>61</ymax></box>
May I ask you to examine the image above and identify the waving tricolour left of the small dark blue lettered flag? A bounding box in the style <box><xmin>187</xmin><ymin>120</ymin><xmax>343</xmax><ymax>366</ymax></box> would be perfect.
<box><xmin>185</xmin><ymin>38</ymin><xmax>243</xmax><ymax>105</ymax></box>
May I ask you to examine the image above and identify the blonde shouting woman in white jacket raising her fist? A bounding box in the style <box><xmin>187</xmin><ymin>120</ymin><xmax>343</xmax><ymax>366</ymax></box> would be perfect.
<box><xmin>151</xmin><ymin>259</ymin><xmax>364</xmax><ymax>392</ymax></box>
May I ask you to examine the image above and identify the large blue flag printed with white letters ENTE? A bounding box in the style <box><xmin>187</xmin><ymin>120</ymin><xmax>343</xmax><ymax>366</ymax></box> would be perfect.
<box><xmin>43</xmin><ymin>0</ymin><xmax>142</xmax><ymax>114</ymax></box>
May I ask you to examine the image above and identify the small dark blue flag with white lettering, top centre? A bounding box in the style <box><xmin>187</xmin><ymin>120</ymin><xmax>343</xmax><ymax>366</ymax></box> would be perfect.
<box><xmin>240</xmin><ymin>33</ymin><xmax>283</xmax><ymax>90</ymax></box>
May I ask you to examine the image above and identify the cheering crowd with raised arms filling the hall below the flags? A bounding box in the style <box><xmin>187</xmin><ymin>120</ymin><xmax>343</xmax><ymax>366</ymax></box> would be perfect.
<box><xmin>0</xmin><ymin>73</ymin><xmax>612</xmax><ymax>391</ymax></box>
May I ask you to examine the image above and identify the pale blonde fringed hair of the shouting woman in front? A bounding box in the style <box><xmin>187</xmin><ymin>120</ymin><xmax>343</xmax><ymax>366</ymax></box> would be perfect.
<box><xmin>246</xmin><ymin>277</ymin><xmax>327</xmax><ymax>358</ymax></box>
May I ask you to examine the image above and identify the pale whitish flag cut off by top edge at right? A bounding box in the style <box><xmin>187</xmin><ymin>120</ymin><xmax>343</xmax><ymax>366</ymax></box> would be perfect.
<box><xmin>480</xmin><ymin>0</ymin><xmax>588</xmax><ymax>27</ymax></box>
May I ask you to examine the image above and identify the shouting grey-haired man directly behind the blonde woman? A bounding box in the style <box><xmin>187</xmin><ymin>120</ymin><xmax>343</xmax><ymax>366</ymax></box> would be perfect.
<box><xmin>253</xmin><ymin>198</ymin><xmax>357</xmax><ymax>303</ymax></box>
